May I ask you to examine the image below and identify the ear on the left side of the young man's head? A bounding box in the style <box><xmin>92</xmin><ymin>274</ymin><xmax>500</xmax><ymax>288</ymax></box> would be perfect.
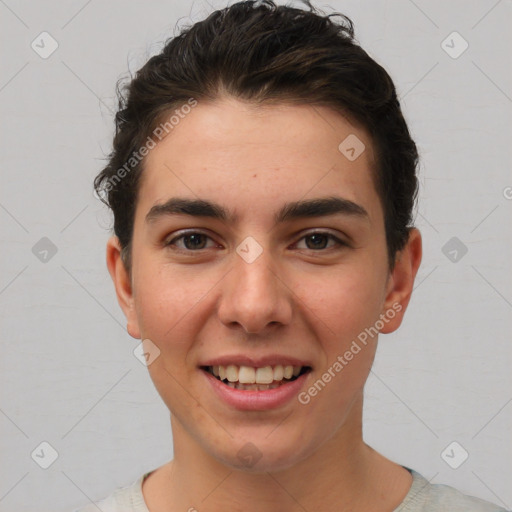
<box><xmin>107</xmin><ymin>236</ymin><xmax>141</xmax><ymax>339</ymax></box>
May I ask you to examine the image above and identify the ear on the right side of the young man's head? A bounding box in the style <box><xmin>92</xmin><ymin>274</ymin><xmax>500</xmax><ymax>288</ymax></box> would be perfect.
<box><xmin>380</xmin><ymin>228</ymin><xmax>422</xmax><ymax>334</ymax></box>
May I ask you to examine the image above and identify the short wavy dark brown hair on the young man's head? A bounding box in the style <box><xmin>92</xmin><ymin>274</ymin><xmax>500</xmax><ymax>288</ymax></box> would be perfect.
<box><xmin>94</xmin><ymin>0</ymin><xmax>418</xmax><ymax>273</ymax></box>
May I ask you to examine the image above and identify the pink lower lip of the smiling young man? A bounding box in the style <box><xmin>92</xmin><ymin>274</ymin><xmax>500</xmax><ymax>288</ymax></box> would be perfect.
<box><xmin>200</xmin><ymin>369</ymin><xmax>311</xmax><ymax>411</ymax></box>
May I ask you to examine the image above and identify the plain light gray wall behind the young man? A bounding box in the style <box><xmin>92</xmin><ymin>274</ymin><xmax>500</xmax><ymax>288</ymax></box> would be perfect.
<box><xmin>0</xmin><ymin>0</ymin><xmax>512</xmax><ymax>512</ymax></box>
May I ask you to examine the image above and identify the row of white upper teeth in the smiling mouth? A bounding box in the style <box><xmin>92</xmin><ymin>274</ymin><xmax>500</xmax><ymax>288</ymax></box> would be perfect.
<box><xmin>210</xmin><ymin>364</ymin><xmax>302</xmax><ymax>384</ymax></box>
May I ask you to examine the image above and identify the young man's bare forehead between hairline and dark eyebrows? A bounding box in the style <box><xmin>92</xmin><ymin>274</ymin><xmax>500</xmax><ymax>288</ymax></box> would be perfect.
<box><xmin>136</xmin><ymin>99</ymin><xmax>380</xmax><ymax>227</ymax></box>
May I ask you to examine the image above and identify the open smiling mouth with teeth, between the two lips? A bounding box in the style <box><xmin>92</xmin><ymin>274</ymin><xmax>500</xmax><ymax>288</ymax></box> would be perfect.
<box><xmin>200</xmin><ymin>364</ymin><xmax>312</xmax><ymax>391</ymax></box>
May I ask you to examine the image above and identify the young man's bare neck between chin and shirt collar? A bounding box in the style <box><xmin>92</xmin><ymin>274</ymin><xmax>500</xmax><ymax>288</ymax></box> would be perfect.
<box><xmin>148</xmin><ymin>394</ymin><xmax>410</xmax><ymax>512</ymax></box>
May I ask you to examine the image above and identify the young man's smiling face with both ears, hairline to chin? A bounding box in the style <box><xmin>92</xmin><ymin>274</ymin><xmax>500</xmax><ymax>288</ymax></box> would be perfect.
<box><xmin>108</xmin><ymin>99</ymin><xmax>419</xmax><ymax>470</ymax></box>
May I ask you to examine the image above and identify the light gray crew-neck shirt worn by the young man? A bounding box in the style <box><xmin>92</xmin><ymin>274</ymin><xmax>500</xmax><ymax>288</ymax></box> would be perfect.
<box><xmin>74</xmin><ymin>466</ymin><xmax>512</xmax><ymax>512</ymax></box>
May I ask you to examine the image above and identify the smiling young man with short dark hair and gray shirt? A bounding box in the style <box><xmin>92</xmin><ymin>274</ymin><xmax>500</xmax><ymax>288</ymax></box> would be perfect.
<box><xmin>75</xmin><ymin>1</ymin><xmax>503</xmax><ymax>512</ymax></box>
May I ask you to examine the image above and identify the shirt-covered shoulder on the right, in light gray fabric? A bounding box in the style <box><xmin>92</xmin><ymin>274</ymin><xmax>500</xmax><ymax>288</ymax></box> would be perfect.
<box><xmin>394</xmin><ymin>468</ymin><xmax>507</xmax><ymax>512</ymax></box>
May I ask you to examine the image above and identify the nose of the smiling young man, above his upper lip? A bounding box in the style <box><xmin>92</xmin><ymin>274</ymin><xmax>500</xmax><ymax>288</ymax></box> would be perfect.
<box><xmin>218</xmin><ymin>242</ymin><xmax>293</xmax><ymax>334</ymax></box>
